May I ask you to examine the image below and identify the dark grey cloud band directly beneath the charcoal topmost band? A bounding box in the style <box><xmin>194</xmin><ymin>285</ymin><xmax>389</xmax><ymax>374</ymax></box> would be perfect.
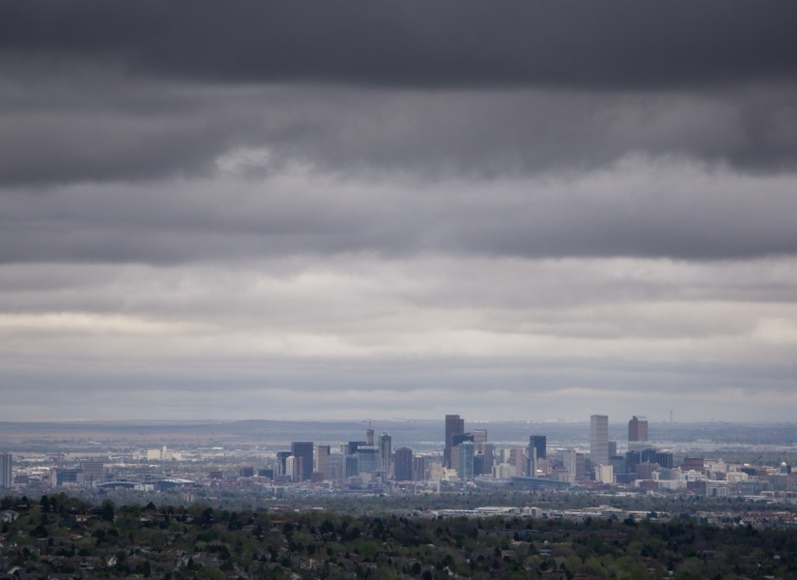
<box><xmin>0</xmin><ymin>77</ymin><xmax>797</xmax><ymax>185</ymax></box>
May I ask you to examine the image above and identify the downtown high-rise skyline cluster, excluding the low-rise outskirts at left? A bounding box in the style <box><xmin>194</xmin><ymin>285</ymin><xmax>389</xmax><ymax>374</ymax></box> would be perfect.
<box><xmin>207</xmin><ymin>414</ymin><xmax>797</xmax><ymax>496</ymax></box>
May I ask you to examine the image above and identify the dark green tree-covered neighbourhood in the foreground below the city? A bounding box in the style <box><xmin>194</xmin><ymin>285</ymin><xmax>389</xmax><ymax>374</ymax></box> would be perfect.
<box><xmin>0</xmin><ymin>494</ymin><xmax>797</xmax><ymax>580</ymax></box>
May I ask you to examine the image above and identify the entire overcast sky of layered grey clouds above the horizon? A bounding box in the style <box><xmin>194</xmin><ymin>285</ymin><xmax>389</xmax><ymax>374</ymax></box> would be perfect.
<box><xmin>0</xmin><ymin>0</ymin><xmax>797</xmax><ymax>422</ymax></box>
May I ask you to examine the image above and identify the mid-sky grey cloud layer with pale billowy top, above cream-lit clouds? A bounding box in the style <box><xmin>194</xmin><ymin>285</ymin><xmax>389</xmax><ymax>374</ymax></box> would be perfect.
<box><xmin>0</xmin><ymin>157</ymin><xmax>797</xmax><ymax>264</ymax></box>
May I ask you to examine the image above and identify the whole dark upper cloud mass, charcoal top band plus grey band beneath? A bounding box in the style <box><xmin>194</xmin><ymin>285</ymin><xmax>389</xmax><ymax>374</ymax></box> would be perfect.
<box><xmin>0</xmin><ymin>2</ymin><xmax>797</xmax><ymax>185</ymax></box>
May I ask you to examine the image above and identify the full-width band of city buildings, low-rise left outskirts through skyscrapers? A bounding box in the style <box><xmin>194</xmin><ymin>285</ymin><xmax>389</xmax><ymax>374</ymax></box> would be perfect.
<box><xmin>0</xmin><ymin>414</ymin><xmax>797</xmax><ymax>497</ymax></box>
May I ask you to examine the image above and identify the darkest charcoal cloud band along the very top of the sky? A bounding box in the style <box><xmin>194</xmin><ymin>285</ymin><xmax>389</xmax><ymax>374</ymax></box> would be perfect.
<box><xmin>0</xmin><ymin>1</ymin><xmax>797</xmax><ymax>88</ymax></box>
